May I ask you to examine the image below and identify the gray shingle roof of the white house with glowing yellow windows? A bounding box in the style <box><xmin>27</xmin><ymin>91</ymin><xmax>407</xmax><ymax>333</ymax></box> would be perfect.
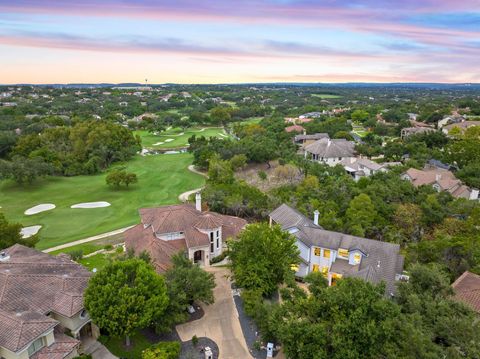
<box><xmin>270</xmin><ymin>204</ymin><xmax>403</xmax><ymax>294</ymax></box>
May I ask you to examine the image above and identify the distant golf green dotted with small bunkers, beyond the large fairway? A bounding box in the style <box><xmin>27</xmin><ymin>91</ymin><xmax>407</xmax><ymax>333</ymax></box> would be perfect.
<box><xmin>134</xmin><ymin>127</ymin><xmax>228</xmax><ymax>149</ymax></box>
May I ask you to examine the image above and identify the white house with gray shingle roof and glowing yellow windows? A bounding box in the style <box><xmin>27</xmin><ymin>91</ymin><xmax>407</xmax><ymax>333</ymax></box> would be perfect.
<box><xmin>270</xmin><ymin>204</ymin><xmax>404</xmax><ymax>295</ymax></box>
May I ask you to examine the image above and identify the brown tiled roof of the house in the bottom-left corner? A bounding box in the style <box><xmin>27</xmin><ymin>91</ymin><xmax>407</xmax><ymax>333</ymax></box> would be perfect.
<box><xmin>0</xmin><ymin>244</ymin><xmax>91</xmax><ymax>352</ymax></box>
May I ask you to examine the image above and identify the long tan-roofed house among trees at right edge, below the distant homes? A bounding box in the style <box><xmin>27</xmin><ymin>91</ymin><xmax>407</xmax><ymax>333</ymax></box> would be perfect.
<box><xmin>402</xmin><ymin>166</ymin><xmax>479</xmax><ymax>200</ymax></box>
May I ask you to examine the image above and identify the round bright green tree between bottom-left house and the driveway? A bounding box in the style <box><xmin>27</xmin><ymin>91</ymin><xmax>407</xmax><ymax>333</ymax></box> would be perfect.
<box><xmin>84</xmin><ymin>258</ymin><xmax>168</xmax><ymax>346</ymax></box>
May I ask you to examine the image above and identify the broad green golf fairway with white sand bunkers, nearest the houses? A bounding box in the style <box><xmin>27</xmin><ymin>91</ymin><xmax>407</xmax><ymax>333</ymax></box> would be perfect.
<box><xmin>0</xmin><ymin>153</ymin><xmax>205</xmax><ymax>249</ymax></box>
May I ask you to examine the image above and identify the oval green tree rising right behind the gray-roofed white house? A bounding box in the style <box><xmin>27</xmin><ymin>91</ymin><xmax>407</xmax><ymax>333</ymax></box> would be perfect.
<box><xmin>346</xmin><ymin>193</ymin><xmax>376</xmax><ymax>237</ymax></box>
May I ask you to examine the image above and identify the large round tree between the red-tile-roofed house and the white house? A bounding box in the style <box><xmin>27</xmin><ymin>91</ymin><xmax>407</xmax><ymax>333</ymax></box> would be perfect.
<box><xmin>229</xmin><ymin>223</ymin><xmax>299</xmax><ymax>296</ymax></box>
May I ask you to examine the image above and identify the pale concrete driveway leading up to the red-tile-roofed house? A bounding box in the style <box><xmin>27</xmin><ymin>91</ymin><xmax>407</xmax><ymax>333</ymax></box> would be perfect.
<box><xmin>177</xmin><ymin>267</ymin><xmax>252</xmax><ymax>359</ymax></box>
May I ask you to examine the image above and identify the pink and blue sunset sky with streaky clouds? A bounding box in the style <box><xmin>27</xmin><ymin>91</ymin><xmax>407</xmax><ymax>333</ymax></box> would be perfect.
<box><xmin>0</xmin><ymin>0</ymin><xmax>480</xmax><ymax>84</ymax></box>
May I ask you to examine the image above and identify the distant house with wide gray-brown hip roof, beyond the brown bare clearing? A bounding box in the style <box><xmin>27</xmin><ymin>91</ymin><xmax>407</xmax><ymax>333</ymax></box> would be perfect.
<box><xmin>303</xmin><ymin>138</ymin><xmax>355</xmax><ymax>166</ymax></box>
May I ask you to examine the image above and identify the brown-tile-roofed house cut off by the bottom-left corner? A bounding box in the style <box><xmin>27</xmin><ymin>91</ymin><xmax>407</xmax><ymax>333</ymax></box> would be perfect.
<box><xmin>0</xmin><ymin>244</ymin><xmax>98</xmax><ymax>359</ymax></box>
